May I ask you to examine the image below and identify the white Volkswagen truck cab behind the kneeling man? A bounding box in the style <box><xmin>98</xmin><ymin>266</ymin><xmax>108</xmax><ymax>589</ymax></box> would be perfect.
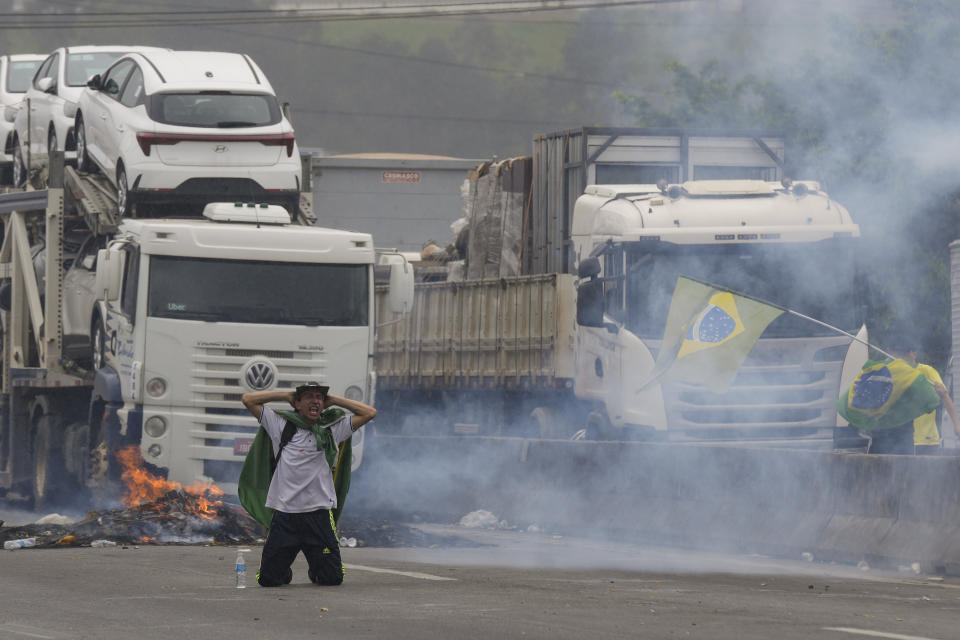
<box><xmin>92</xmin><ymin>204</ymin><xmax>400</xmax><ymax>492</ymax></box>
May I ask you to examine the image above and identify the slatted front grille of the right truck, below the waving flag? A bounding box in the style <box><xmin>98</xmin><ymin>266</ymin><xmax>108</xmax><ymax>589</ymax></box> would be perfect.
<box><xmin>664</xmin><ymin>336</ymin><xmax>850</xmax><ymax>437</ymax></box>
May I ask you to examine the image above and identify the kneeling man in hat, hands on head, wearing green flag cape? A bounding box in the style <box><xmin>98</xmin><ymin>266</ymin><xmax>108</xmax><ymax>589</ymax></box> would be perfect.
<box><xmin>237</xmin><ymin>382</ymin><xmax>377</xmax><ymax>587</ymax></box>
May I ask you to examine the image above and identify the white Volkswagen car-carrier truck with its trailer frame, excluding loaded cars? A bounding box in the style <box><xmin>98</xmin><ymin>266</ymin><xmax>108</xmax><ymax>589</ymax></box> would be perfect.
<box><xmin>0</xmin><ymin>152</ymin><xmax>413</xmax><ymax>506</ymax></box>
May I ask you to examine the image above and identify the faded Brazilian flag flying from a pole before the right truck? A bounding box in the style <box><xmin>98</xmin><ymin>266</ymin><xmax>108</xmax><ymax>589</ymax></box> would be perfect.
<box><xmin>641</xmin><ymin>276</ymin><xmax>785</xmax><ymax>393</ymax></box>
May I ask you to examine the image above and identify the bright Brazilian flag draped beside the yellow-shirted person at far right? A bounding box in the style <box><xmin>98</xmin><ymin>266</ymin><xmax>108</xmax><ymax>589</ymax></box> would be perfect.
<box><xmin>837</xmin><ymin>358</ymin><xmax>940</xmax><ymax>431</ymax></box>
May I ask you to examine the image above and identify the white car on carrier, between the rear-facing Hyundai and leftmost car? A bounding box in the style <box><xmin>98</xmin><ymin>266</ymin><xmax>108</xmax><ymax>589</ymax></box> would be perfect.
<box><xmin>13</xmin><ymin>46</ymin><xmax>169</xmax><ymax>186</ymax></box>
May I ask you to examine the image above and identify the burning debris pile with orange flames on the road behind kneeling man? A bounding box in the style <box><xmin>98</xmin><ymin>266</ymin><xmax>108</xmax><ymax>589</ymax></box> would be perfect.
<box><xmin>0</xmin><ymin>446</ymin><xmax>480</xmax><ymax>547</ymax></box>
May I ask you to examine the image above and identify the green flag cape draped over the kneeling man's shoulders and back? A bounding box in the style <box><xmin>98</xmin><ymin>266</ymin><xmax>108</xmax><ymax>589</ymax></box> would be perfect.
<box><xmin>237</xmin><ymin>407</ymin><xmax>353</xmax><ymax>529</ymax></box>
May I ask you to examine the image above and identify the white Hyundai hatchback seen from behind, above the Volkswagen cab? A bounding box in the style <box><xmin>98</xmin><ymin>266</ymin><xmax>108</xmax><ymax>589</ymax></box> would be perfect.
<box><xmin>75</xmin><ymin>51</ymin><xmax>302</xmax><ymax>215</ymax></box>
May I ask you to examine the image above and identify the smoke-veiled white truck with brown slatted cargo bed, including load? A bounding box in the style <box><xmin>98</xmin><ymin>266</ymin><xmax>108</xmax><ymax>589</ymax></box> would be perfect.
<box><xmin>376</xmin><ymin>129</ymin><xmax>867</xmax><ymax>445</ymax></box>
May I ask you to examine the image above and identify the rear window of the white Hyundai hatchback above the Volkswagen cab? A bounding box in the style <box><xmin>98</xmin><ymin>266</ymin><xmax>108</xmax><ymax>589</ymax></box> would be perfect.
<box><xmin>148</xmin><ymin>92</ymin><xmax>281</xmax><ymax>129</ymax></box>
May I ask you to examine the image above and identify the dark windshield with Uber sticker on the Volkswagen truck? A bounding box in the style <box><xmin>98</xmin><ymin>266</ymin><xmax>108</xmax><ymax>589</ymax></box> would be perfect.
<box><xmin>147</xmin><ymin>256</ymin><xmax>370</xmax><ymax>327</ymax></box>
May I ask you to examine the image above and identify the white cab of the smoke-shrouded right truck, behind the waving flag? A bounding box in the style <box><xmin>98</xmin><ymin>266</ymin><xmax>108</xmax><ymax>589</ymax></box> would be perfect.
<box><xmin>571</xmin><ymin>180</ymin><xmax>867</xmax><ymax>438</ymax></box>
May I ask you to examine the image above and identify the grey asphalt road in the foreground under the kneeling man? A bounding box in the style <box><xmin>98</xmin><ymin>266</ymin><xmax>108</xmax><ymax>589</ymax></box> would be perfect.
<box><xmin>0</xmin><ymin>526</ymin><xmax>960</xmax><ymax>640</ymax></box>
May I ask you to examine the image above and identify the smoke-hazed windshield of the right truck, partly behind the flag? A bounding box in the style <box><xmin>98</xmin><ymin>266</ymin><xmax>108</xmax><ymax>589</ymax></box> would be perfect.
<box><xmin>622</xmin><ymin>238</ymin><xmax>866</xmax><ymax>340</ymax></box>
